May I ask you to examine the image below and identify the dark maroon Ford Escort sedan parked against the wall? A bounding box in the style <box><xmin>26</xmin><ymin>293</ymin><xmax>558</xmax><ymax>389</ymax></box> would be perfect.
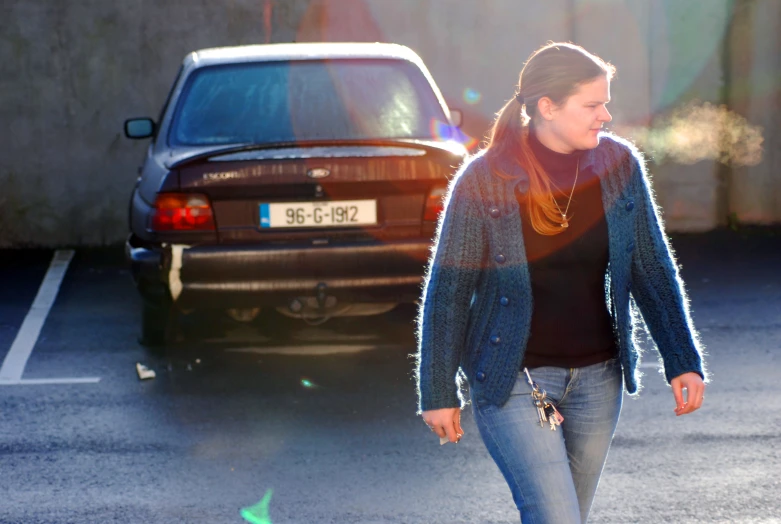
<box><xmin>125</xmin><ymin>44</ymin><xmax>466</xmax><ymax>345</ymax></box>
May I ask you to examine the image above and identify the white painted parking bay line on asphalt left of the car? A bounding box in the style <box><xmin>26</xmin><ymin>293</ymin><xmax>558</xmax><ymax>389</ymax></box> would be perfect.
<box><xmin>0</xmin><ymin>250</ymin><xmax>100</xmax><ymax>386</ymax></box>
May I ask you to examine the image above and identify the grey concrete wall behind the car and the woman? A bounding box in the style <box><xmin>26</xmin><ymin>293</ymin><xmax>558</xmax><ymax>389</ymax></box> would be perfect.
<box><xmin>0</xmin><ymin>0</ymin><xmax>781</xmax><ymax>246</ymax></box>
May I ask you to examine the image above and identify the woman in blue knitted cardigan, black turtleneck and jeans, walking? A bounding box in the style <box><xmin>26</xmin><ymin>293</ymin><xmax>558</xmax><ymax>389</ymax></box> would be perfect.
<box><xmin>416</xmin><ymin>43</ymin><xmax>707</xmax><ymax>524</ymax></box>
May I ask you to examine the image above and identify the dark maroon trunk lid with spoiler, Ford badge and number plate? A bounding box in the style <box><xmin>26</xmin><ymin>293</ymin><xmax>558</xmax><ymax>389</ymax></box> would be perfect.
<box><xmin>172</xmin><ymin>141</ymin><xmax>463</xmax><ymax>243</ymax></box>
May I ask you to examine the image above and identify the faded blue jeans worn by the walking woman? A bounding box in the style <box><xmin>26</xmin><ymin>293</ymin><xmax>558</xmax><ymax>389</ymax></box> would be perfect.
<box><xmin>472</xmin><ymin>358</ymin><xmax>623</xmax><ymax>524</ymax></box>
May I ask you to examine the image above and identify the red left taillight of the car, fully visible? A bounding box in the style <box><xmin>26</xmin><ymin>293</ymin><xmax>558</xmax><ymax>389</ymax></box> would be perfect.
<box><xmin>151</xmin><ymin>193</ymin><xmax>214</xmax><ymax>231</ymax></box>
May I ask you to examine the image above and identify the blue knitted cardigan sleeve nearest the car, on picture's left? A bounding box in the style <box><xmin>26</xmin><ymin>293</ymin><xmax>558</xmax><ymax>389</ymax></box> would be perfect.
<box><xmin>415</xmin><ymin>160</ymin><xmax>484</xmax><ymax>414</ymax></box>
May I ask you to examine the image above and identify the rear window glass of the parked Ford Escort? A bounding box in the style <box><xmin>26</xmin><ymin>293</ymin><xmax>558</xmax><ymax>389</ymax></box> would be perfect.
<box><xmin>169</xmin><ymin>59</ymin><xmax>445</xmax><ymax>145</ymax></box>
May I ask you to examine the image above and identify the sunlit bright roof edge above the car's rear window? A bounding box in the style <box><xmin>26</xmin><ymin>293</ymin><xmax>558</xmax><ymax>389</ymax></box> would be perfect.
<box><xmin>185</xmin><ymin>42</ymin><xmax>420</xmax><ymax>67</ymax></box>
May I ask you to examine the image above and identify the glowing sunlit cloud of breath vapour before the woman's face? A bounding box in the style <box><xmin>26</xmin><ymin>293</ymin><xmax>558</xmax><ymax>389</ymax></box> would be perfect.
<box><xmin>619</xmin><ymin>102</ymin><xmax>764</xmax><ymax>166</ymax></box>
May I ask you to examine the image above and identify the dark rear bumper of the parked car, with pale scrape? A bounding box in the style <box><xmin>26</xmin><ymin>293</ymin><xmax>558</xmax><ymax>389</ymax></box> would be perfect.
<box><xmin>125</xmin><ymin>235</ymin><xmax>431</xmax><ymax>308</ymax></box>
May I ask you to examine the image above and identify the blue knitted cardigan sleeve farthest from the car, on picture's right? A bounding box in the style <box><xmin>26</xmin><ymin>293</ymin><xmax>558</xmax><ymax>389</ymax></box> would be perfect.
<box><xmin>631</xmin><ymin>155</ymin><xmax>708</xmax><ymax>383</ymax></box>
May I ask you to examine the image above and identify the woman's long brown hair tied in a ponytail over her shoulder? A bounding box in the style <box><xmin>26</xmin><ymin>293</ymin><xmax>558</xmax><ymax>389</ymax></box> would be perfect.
<box><xmin>486</xmin><ymin>42</ymin><xmax>616</xmax><ymax>235</ymax></box>
